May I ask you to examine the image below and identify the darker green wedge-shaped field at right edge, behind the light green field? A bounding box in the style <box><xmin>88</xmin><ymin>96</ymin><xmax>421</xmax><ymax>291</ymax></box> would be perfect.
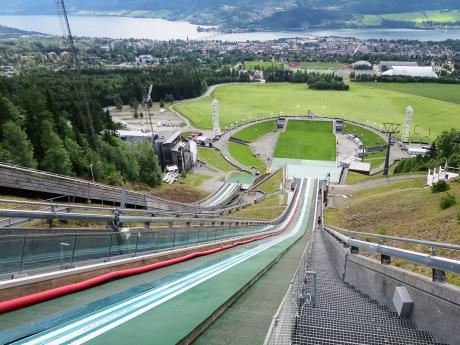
<box><xmin>366</xmin><ymin>83</ymin><xmax>460</xmax><ymax>104</ymax></box>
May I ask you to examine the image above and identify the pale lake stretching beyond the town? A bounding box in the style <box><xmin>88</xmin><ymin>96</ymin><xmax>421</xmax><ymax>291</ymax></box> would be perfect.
<box><xmin>0</xmin><ymin>15</ymin><xmax>460</xmax><ymax>42</ymax></box>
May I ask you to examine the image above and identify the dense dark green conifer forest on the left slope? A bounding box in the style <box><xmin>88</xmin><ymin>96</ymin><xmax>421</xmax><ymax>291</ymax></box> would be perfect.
<box><xmin>0</xmin><ymin>65</ymin><xmax>245</xmax><ymax>186</ymax></box>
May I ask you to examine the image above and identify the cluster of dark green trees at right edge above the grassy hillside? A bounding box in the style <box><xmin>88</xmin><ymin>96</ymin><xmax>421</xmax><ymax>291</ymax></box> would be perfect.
<box><xmin>395</xmin><ymin>129</ymin><xmax>460</xmax><ymax>174</ymax></box>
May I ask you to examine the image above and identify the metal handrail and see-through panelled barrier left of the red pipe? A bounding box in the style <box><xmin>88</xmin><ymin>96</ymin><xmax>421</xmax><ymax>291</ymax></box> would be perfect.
<box><xmin>0</xmin><ymin>177</ymin><xmax>303</xmax><ymax>280</ymax></box>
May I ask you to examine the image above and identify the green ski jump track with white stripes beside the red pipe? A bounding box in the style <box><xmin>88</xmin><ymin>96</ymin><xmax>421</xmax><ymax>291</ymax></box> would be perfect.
<box><xmin>0</xmin><ymin>179</ymin><xmax>318</xmax><ymax>345</ymax></box>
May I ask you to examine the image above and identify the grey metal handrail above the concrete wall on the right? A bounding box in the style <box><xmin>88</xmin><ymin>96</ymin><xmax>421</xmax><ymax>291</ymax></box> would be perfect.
<box><xmin>324</xmin><ymin>227</ymin><xmax>460</xmax><ymax>274</ymax></box>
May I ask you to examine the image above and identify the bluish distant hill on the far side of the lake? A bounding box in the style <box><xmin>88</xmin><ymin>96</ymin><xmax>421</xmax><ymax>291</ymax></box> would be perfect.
<box><xmin>0</xmin><ymin>0</ymin><xmax>460</xmax><ymax>29</ymax></box>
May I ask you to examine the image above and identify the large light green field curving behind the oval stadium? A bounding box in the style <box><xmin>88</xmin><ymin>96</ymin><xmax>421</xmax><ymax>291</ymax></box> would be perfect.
<box><xmin>176</xmin><ymin>83</ymin><xmax>460</xmax><ymax>138</ymax></box>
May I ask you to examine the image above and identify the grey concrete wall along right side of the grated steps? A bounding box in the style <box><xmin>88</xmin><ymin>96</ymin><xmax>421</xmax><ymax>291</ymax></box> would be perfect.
<box><xmin>322</xmin><ymin>228</ymin><xmax>460</xmax><ymax>344</ymax></box>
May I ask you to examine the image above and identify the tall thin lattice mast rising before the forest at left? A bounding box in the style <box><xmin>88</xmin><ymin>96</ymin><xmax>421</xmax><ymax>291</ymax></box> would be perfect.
<box><xmin>55</xmin><ymin>0</ymin><xmax>100</xmax><ymax>153</ymax></box>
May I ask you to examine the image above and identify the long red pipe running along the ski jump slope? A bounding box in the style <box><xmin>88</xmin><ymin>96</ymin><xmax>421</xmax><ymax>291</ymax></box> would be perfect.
<box><xmin>0</xmin><ymin>192</ymin><xmax>299</xmax><ymax>314</ymax></box>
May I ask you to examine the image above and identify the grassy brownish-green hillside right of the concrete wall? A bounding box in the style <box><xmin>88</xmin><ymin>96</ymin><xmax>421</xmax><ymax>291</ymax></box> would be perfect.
<box><xmin>326</xmin><ymin>178</ymin><xmax>460</xmax><ymax>285</ymax></box>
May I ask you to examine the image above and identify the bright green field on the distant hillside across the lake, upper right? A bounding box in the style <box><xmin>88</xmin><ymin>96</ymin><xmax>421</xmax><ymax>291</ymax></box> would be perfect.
<box><xmin>361</xmin><ymin>10</ymin><xmax>460</xmax><ymax>26</ymax></box>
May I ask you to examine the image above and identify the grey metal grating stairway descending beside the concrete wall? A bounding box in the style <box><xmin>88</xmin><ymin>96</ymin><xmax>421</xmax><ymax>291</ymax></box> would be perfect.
<box><xmin>292</xmin><ymin>230</ymin><xmax>446</xmax><ymax>345</ymax></box>
